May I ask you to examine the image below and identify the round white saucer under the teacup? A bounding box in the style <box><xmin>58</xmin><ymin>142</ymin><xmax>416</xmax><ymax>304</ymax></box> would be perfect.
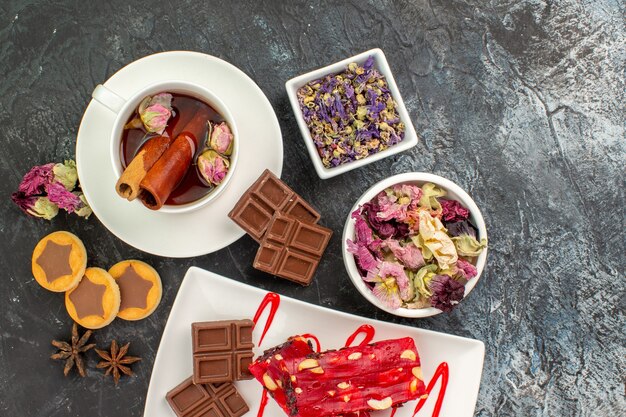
<box><xmin>76</xmin><ymin>51</ymin><xmax>283</xmax><ymax>258</ymax></box>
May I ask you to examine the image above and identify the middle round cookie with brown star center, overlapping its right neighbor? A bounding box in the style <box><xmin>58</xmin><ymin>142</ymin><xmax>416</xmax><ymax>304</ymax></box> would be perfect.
<box><xmin>65</xmin><ymin>268</ymin><xmax>120</xmax><ymax>329</ymax></box>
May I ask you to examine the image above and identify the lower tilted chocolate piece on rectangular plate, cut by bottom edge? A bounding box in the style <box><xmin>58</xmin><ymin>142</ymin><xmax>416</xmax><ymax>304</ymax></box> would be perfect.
<box><xmin>166</xmin><ymin>377</ymin><xmax>249</xmax><ymax>417</ymax></box>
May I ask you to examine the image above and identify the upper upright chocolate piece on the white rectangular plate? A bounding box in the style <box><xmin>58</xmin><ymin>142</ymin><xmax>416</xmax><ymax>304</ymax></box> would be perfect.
<box><xmin>191</xmin><ymin>320</ymin><xmax>254</xmax><ymax>384</ymax></box>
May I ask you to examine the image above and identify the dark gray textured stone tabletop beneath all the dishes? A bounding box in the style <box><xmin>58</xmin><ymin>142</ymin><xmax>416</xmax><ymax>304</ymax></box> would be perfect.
<box><xmin>0</xmin><ymin>0</ymin><xmax>626</xmax><ymax>417</ymax></box>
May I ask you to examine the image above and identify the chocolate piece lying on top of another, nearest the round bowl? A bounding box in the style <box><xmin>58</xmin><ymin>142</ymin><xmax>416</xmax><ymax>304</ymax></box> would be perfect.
<box><xmin>253</xmin><ymin>212</ymin><xmax>333</xmax><ymax>285</ymax></box>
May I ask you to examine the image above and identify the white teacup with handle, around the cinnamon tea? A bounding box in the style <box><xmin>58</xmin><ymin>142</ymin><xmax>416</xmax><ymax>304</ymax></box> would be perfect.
<box><xmin>91</xmin><ymin>80</ymin><xmax>239</xmax><ymax>213</ymax></box>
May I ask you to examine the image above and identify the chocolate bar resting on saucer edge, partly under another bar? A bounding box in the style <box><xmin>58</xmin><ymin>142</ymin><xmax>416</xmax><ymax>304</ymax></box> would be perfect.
<box><xmin>228</xmin><ymin>169</ymin><xmax>320</xmax><ymax>242</ymax></box>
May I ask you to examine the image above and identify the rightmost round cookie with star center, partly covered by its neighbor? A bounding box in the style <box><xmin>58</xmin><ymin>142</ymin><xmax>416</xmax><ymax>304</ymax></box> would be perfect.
<box><xmin>109</xmin><ymin>259</ymin><xmax>163</xmax><ymax>320</ymax></box>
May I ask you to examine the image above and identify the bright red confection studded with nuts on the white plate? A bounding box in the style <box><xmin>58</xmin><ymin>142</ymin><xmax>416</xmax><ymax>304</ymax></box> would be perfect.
<box><xmin>250</xmin><ymin>337</ymin><xmax>426</xmax><ymax>417</ymax></box>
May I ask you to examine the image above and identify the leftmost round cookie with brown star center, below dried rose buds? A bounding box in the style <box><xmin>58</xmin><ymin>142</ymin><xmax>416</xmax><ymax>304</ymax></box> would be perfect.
<box><xmin>31</xmin><ymin>231</ymin><xmax>87</xmax><ymax>292</ymax></box>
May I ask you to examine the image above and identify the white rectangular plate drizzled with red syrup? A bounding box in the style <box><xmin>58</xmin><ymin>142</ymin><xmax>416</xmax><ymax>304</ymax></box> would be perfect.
<box><xmin>144</xmin><ymin>267</ymin><xmax>485</xmax><ymax>417</ymax></box>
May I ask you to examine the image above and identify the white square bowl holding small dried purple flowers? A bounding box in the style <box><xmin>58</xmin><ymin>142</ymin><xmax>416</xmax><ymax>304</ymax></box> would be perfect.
<box><xmin>285</xmin><ymin>48</ymin><xmax>417</xmax><ymax>179</ymax></box>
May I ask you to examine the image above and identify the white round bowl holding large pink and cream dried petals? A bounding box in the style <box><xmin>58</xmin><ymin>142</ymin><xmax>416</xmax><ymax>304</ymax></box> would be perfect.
<box><xmin>342</xmin><ymin>172</ymin><xmax>487</xmax><ymax>318</ymax></box>
